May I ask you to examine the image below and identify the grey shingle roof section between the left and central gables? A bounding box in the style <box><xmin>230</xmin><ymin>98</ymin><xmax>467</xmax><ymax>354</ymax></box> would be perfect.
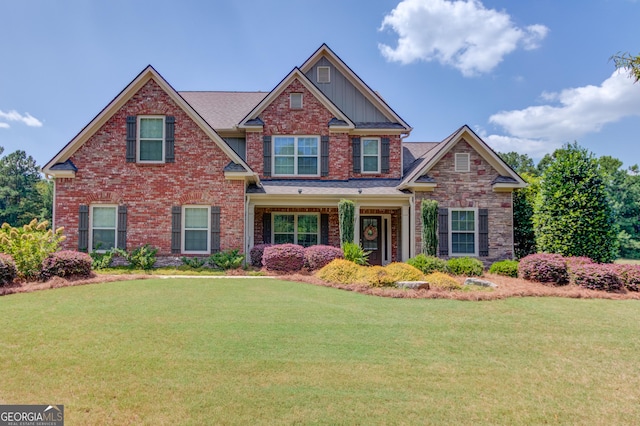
<box><xmin>179</xmin><ymin>92</ymin><xmax>268</xmax><ymax>130</ymax></box>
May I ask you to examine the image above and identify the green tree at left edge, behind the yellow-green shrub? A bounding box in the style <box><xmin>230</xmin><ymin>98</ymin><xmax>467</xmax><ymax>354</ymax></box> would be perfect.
<box><xmin>0</xmin><ymin>150</ymin><xmax>53</xmax><ymax>226</ymax></box>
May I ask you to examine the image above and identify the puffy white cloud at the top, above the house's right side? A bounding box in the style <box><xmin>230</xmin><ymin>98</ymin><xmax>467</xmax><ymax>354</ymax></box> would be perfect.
<box><xmin>378</xmin><ymin>0</ymin><xmax>549</xmax><ymax>76</ymax></box>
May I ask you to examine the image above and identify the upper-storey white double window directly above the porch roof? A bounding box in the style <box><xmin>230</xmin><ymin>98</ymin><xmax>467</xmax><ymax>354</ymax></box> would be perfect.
<box><xmin>273</xmin><ymin>136</ymin><xmax>320</xmax><ymax>176</ymax></box>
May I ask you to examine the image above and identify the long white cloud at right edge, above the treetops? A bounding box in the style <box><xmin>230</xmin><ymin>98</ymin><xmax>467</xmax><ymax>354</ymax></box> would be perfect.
<box><xmin>483</xmin><ymin>71</ymin><xmax>640</xmax><ymax>156</ymax></box>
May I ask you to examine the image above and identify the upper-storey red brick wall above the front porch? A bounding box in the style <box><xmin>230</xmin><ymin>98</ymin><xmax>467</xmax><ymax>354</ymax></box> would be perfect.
<box><xmin>247</xmin><ymin>80</ymin><xmax>402</xmax><ymax>180</ymax></box>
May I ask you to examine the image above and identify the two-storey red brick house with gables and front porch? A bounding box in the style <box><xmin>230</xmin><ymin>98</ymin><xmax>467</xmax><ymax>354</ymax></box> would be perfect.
<box><xmin>43</xmin><ymin>45</ymin><xmax>526</xmax><ymax>264</ymax></box>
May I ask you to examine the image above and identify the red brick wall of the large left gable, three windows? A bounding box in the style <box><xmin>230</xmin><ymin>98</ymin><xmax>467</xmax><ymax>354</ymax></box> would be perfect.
<box><xmin>55</xmin><ymin>81</ymin><xmax>244</xmax><ymax>255</ymax></box>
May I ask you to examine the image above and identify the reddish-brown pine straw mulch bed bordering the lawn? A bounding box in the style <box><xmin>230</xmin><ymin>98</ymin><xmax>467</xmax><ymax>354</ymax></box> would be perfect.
<box><xmin>0</xmin><ymin>271</ymin><xmax>640</xmax><ymax>300</ymax></box>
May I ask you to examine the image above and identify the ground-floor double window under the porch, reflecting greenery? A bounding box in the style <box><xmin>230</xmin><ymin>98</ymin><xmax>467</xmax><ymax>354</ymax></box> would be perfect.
<box><xmin>272</xmin><ymin>213</ymin><xmax>320</xmax><ymax>247</ymax></box>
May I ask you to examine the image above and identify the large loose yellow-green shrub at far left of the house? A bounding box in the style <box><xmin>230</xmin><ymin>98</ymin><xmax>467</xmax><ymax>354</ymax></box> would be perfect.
<box><xmin>0</xmin><ymin>219</ymin><xmax>65</xmax><ymax>279</ymax></box>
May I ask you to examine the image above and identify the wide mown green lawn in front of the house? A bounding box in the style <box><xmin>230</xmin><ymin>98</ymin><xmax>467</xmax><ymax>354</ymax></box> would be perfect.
<box><xmin>0</xmin><ymin>278</ymin><xmax>640</xmax><ymax>425</ymax></box>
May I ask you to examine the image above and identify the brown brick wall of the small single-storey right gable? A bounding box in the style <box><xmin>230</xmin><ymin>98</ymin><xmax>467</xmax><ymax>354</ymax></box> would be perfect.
<box><xmin>415</xmin><ymin>139</ymin><xmax>513</xmax><ymax>263</ymax></box>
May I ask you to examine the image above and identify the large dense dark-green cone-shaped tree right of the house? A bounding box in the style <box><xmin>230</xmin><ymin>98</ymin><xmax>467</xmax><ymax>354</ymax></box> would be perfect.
<box><xmin>533</xmin><ymin>142</ymin><xmax>618</xmax><ymax>262</ymax></box>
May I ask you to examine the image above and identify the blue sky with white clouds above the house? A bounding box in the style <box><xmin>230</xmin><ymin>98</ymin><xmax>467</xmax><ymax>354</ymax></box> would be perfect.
<box><xmin>0</xmin><ymin>0</ymin><xmax>640</xmax><ymax>166</ymax></box>
